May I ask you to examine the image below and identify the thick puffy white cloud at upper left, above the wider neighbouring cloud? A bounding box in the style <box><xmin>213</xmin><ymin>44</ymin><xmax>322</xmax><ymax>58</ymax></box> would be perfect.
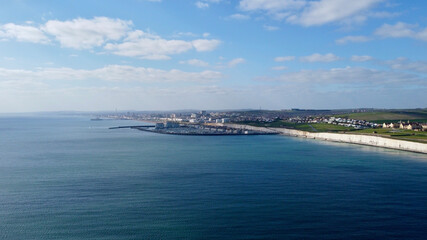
<box><xmin>42</xmin><ymin>17</ymin><xmax>132</xmax><ymax>49</ymax></box>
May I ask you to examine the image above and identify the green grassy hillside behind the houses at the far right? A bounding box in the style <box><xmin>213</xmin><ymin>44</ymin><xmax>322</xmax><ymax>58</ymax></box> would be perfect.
<box><xmin>337</xmin><ymin>109</ymin><xmax>427</xmax><ymax>123</ymax></box>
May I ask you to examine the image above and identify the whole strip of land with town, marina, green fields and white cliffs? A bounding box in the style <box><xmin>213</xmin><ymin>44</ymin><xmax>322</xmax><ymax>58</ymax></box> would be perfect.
<box><xmin>97</xmin><ymin>108</ymin><xmax>427</xmax><ymax>154</ymax></box>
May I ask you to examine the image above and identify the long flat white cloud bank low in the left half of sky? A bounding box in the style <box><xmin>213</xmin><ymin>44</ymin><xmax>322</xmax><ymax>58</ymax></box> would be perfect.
<box><xmin>0</xmin><ymin>65</ymin><xmax>222</xmax><ymax>82</ymax></box>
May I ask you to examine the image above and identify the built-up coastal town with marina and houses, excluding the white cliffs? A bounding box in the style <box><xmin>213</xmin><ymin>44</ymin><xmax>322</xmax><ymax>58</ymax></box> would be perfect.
<box><xmin>98</xmin><ymin>109</ymin><xmax>427</xmax><ymax>135</ymax></box>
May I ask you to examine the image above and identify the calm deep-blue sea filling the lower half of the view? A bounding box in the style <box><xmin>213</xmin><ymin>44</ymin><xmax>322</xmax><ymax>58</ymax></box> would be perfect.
<box><xmin>0</xmin><ymin>116</ymin><xmax>427</xmax><ymax>239</ymax></box>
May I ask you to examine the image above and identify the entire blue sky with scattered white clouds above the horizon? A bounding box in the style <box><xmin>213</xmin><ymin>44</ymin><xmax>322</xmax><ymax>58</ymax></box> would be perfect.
<box><xmin>0</xmin><ymin>0</ymin><xmax>427</xmax><ymax>113</ymax></box>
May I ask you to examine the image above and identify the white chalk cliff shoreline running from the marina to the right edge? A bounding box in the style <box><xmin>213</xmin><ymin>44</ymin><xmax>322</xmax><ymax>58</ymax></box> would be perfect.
<box><xmin>222</xmin><ymin>123</ymin><xmax>427</xmax><ymax>154</ymax></box>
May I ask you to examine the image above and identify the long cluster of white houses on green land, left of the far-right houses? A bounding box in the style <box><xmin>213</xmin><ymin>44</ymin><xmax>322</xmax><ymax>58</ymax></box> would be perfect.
<box><xmin>287</xmin><ymin>116</ymin><xmax>379</xmax><ymax>129</ymax></box>
